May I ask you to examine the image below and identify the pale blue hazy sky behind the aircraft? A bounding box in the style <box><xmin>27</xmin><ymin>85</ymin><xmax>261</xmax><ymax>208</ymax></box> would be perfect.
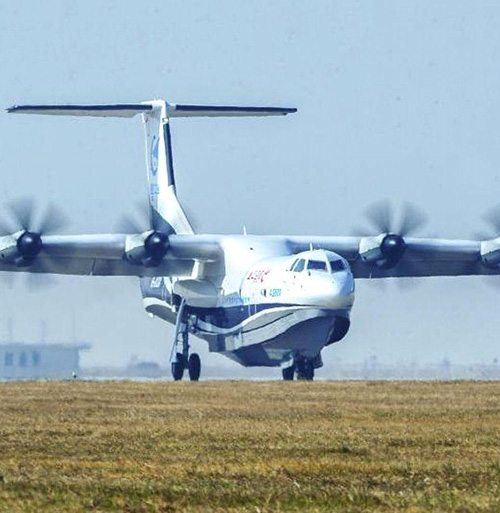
<box><xmin>0</xmin><ymin>0</ymin><xmax>500</xmax><ymax>365</ymax></box>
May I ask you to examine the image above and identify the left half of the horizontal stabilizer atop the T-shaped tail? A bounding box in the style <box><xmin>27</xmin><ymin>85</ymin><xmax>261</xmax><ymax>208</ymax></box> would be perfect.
<box><xmin>7</xmin><ymin>103</ymin><xmax>153</xmax><ymax>118</ymax></box>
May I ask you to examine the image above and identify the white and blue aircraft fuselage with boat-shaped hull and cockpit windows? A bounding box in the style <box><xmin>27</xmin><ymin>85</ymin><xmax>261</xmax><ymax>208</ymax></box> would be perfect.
<box><xmin>142</xmin><ymin>236</ymin><xmax>354</xmax><ymax>367</ymax></box>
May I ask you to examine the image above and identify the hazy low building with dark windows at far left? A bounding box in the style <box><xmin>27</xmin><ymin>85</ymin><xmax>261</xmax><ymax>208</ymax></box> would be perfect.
<box><xmin>0</xmin><ymin>342</ymin><xmax>90</xmax><ymax>379</ymax></box>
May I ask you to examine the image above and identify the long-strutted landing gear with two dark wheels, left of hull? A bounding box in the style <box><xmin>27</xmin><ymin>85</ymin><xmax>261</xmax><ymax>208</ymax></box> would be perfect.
<box><xmin>170</xmin><ymin>300</ymin><xmax>201</xmax><ymax>381</ymax></box>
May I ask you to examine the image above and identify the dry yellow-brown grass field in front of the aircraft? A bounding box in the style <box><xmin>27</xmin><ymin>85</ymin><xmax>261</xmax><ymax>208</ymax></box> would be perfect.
<box><xmin>0</xmin><ymin>381</ymin><xmax>500</xmax><ymax>512</ymax></box>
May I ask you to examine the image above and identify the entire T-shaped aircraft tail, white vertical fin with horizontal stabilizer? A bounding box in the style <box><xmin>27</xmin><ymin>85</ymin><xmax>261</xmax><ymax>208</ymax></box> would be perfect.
<box><xmin>7</xmin><ymin>100</ymin><xmax>297</xmax><ymax>234</ymax></box>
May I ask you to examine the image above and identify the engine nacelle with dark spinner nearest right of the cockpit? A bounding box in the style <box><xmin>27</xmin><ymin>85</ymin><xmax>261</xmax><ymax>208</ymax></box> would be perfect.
<box><xmin>359</xmin><ymin>233</ymin><xmax>406</xmax><ymax>269</ymax></box>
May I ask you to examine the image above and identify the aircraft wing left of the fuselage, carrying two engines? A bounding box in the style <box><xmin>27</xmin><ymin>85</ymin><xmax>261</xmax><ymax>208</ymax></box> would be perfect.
<box><xmin>0</xmin><ymin>231</ymin><xmax>221</xmax><ymax>277</ymax></box>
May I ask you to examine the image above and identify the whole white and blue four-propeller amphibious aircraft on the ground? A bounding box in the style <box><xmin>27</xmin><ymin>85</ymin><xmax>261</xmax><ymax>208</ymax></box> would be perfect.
<box><xmin>0</xmin><ymin>100</ymin><xmax>500</xmax><ymax>381</ymax></box>
